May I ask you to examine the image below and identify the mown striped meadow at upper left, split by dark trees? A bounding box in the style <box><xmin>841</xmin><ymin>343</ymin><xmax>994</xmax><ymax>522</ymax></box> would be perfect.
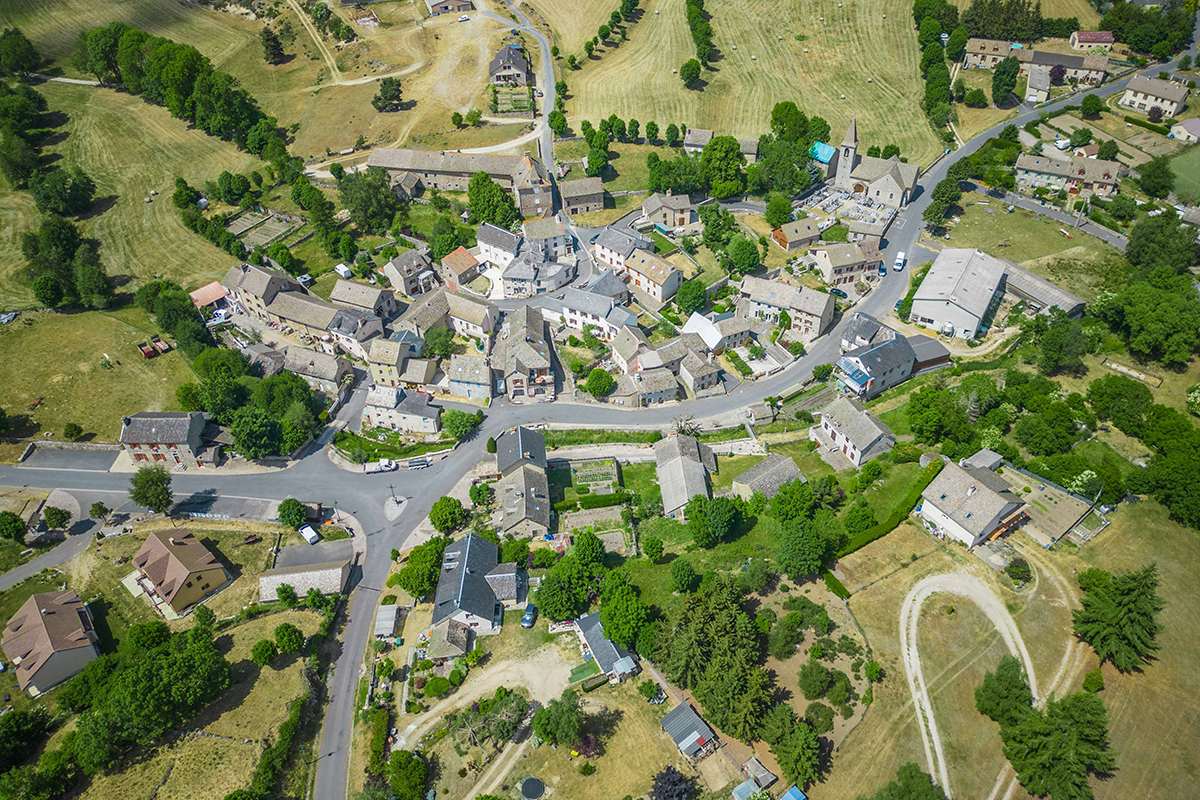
<box><xmin>0</xmin><ymin>83</ymin><xmax>263</xmax><ymax>309</ymax></box>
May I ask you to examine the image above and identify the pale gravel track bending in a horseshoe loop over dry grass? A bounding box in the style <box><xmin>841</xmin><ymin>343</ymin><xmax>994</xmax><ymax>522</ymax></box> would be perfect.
<box><xmin>900</xmin><ymin>572</ymin><xmax>1039</xmax><ymax>798</ymax></box>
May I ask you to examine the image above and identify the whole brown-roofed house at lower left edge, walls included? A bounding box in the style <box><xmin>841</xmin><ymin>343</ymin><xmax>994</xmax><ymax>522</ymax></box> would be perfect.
<box><xmin>0</xmin><ymin>589</ymin><xmax>100</xmax><ymax>697</ymax></box>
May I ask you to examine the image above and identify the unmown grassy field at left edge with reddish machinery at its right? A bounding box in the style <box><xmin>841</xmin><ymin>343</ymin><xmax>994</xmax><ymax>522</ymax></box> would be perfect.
<box><xmin>0</xmin><ymin>309</ymin><xmax>199</xmax><ymax>441</ymax></box>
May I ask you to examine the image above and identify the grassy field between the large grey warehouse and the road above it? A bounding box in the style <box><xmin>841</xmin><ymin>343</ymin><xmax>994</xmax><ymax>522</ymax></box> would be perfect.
<box><xmin>940</xmin><ymin>192</ymin><xmax>1126</xmax><ymax>301</ymax></box>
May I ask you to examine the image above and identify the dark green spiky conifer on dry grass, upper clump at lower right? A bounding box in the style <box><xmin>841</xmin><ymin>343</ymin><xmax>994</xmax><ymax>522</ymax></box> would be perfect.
<box><xmin>1072</xmin><ymin>564</ymin><xmax>1166</xmax><ymax>672</ymax></box>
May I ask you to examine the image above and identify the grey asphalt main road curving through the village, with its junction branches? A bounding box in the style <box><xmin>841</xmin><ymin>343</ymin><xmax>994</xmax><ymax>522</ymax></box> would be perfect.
<box><xmin>0</xmin><ymin>32</ymin><xmax>1195</xmax><ymax>800</ymax></box>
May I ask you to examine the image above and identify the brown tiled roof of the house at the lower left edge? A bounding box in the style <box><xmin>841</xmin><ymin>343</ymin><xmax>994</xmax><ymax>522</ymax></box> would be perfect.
<box><xmin>2</xmin><ymin>589</ymin><xmax>96</xmax><ymax>690</ymax></box>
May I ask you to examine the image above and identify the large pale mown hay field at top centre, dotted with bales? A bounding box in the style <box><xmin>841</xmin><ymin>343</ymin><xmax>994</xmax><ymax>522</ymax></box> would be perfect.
<box><xmin>556</xmin><ymin>0</ymin><xmax>942</xmax><ymax>163</ymax></box>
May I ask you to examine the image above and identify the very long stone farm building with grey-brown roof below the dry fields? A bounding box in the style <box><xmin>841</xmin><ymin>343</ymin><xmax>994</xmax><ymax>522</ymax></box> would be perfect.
<box><xmin>367</xmin><ymin>148</ymin><xmax>554</xmax><ymax>217</ymax></box>
